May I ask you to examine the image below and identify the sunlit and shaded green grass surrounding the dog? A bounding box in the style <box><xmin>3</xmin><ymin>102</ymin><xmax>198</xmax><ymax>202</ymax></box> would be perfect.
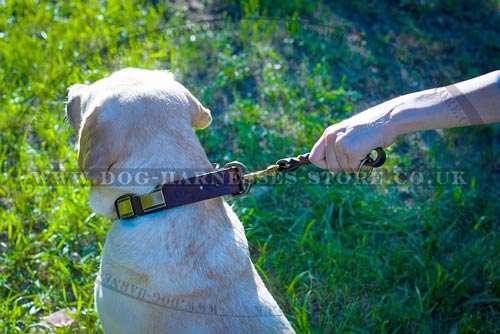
<box><xmin>0</xmin><ymin>0</ymin><xmax>500</xmax><ymax>333</ymax></box>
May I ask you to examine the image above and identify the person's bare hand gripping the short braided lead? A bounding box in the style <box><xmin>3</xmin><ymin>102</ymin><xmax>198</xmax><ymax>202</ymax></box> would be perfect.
<box><xmin>309</xmin><ymin>100</ymin><xmax>402</xmax><ymax>173</ymax></box>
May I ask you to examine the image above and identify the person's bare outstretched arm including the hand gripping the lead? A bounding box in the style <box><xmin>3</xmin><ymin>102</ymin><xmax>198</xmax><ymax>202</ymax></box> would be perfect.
<box><xmin>309</xmin><ymin>71</ymin><xmax>500</xmax><ymax>172</ymax></box>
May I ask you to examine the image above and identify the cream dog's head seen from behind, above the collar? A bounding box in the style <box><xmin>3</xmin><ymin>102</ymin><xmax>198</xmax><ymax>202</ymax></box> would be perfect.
<box><xmin>66</xmin><ymin>68</ymin><xmax>212</xmax><ymax>214</ymax></box>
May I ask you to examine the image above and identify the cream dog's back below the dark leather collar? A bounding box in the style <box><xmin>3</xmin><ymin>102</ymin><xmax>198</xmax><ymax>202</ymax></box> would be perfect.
<box><xmin>96</xmin><ymin>200</ymin><xmax>293</xmax><ymax>333</ymax></box>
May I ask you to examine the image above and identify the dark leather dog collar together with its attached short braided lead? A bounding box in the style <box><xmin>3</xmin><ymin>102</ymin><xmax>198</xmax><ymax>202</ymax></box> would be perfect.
<box><xmin>115</xmin><ymin>147</ymin><xmax>386</xmax><ymax>219</ymax></box>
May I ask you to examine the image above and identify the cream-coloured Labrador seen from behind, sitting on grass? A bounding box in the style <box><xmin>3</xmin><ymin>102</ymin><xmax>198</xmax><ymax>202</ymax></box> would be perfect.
<box><xmin>66</xmin><ymin>68</ymin><xmax>294</xmax><ymax>334</ymax></box>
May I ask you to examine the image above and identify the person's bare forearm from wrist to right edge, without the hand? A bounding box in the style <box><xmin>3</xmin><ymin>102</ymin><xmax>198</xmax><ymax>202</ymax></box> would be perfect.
<box><xmin>389</xmin><ymin>71</ymin><xmax>500</xmax><ymax>137</ymax></box>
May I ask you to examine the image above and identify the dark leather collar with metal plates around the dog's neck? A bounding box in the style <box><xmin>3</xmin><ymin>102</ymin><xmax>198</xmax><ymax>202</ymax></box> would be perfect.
<box><xmin>115</xmin><ymin>162</ymin><xmax>246</xmax><ymax>219</ymax></box>
